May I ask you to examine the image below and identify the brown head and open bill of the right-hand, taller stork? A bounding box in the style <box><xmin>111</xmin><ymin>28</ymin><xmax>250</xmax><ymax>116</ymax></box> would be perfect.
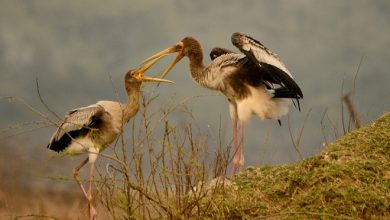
<box><xmin>144</xmin><ymin>37</ymin><xmax>203</xmax><ymax>78</ymax></box>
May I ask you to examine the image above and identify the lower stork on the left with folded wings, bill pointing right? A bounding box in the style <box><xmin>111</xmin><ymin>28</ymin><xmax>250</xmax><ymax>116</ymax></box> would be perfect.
<box><xmin>47</xmin><ymin>62</ymin><xmax>172</xmax><ymax>219</ymax></box>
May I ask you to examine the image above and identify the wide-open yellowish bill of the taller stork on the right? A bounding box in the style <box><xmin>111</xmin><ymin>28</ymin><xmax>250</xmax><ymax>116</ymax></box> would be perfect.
<box><xmin>143</xmin><ymin>42</ymin><xmax>184</xmax><ymax>78</ymax></box>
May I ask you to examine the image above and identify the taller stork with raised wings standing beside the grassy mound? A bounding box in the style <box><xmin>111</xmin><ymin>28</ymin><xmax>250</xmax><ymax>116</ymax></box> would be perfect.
<box><xmin>145</xmin><ymin>33</ymin><xmax>303</xmax><ymax>175</ymax></box>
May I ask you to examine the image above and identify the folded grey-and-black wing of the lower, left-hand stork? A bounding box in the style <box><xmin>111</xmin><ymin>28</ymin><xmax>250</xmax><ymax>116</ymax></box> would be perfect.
<box><xmin>47</xmin><ymin>104</ymin><xmax>106</xmax><ymax>152</ymax></box>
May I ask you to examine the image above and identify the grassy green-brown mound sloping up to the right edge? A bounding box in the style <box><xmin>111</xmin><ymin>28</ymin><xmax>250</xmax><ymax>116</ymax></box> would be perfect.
<box><xmin>209</xmin><ymin>113</ymin><xmax>390</xmax><ymax>219</ymax></box>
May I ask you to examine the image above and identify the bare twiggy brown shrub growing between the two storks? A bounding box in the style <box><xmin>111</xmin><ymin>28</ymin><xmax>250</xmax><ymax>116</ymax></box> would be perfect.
<box><xmin>96</xmin><ymin>94</ymin><xmax>230</xmax><ymax>219</ymax></box>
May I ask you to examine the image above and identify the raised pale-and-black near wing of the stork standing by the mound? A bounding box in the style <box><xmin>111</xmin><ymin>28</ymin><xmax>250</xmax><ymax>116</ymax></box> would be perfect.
<box><xmin>232</xmin><ymin>33</ymin><xmax>303</xmax><ymax>98</ymax></box>
